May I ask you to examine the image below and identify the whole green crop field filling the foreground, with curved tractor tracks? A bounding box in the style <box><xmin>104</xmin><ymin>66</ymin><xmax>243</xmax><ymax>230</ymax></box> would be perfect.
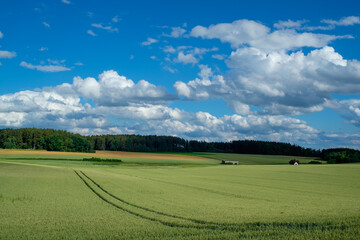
<box><xmin>0</xmin><ymin>154</ymin><xmax>360</xmax><ymax>239</ymax></box>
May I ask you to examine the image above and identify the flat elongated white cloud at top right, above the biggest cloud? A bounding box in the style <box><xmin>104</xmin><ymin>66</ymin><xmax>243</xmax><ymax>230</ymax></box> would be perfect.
<box><xmin>190</xmin><ymin>19</ymin><xmax>352</xmax><ymax>50</ymax></box>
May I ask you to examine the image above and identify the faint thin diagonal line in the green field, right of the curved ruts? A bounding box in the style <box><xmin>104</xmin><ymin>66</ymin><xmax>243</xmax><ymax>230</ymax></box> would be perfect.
<box><xmin>117</xmin><ymin>174</ymin><xmax>271</xmax><ymax>202</ymax></box>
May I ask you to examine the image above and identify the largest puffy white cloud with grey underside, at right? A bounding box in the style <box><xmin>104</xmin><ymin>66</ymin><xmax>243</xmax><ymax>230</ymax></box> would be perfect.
<box><xmin>174</xmin><ymin>47</ymin><xmax>360</xmax><ymax>115</ymax></box>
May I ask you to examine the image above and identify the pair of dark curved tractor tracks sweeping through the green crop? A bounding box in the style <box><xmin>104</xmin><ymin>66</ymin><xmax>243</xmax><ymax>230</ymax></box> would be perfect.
<box><xmin>74</xmin><ymin>170</ymin><xmax>358</xmax><ymax>233</ymax></box>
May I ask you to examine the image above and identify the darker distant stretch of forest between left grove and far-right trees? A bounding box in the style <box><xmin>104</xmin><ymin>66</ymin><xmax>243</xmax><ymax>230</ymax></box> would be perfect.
<box><xmin>87</xmin><ymin>132</ymin><xmax>321</xmax><ymax>157</ymax></box>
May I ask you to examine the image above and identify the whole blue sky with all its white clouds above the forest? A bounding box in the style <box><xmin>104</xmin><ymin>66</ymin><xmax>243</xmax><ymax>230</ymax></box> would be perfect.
<box><xmin>0</xmin><ymin>0</ymin><xmax>360</xmax><ymax>148</ymax></box>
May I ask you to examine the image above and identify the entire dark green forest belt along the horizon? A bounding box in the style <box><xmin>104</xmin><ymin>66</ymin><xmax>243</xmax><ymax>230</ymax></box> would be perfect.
<box><xmin>0</xmin><ymin>128</ymin><xmax>360</xmax><ymax>163</ymax></box>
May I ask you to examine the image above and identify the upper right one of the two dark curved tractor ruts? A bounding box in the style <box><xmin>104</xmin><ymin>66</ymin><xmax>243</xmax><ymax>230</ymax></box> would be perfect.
<box><xmin>80</xmin><ymin>171</ymin><xmax>226</xmax><ymax>224</ymax></box>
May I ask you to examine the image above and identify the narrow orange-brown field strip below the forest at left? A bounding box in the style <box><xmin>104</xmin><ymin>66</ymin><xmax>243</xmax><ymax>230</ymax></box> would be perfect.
<box><xmin>0</xmin><ymin>149</ymin><xmax>209</xmax><ymax>161</ymax></box>
